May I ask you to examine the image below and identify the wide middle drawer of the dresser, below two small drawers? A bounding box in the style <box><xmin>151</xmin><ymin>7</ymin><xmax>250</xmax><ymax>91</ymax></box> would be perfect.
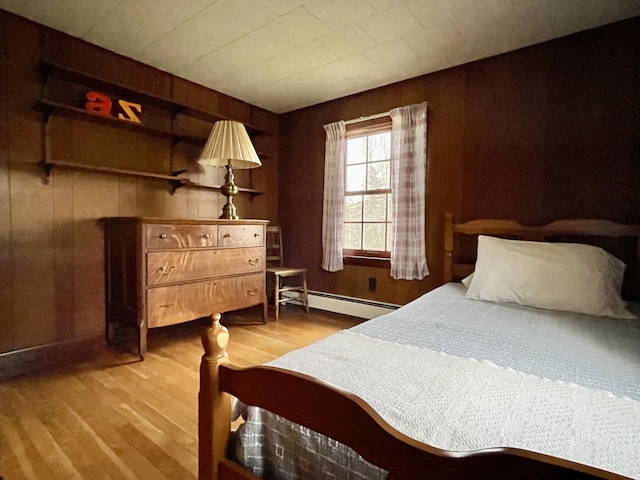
<box><xmin>147</xmin><ymin>247</ymin><xmax>265</xmax><ymax>285</ymax></box>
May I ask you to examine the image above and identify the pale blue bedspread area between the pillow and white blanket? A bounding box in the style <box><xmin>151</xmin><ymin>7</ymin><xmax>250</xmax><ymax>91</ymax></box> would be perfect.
<box><xmin>352</xmin><ymin>283</ymin><xmax>640</xmax><ymax>401</ymax></box>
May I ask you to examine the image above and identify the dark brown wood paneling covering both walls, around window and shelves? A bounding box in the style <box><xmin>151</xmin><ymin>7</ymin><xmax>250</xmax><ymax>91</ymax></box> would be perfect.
<box><xmin>0</xmin><ymin>11</ymin><xmax>640</xmax><ymax>358</ymax></box>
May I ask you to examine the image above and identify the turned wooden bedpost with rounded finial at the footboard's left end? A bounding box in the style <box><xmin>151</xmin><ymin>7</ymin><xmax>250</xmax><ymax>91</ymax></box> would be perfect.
<box><xmin>198</xmin><ymin>313</ymin><xmax>231</xmax><ymax>480</ymax></box>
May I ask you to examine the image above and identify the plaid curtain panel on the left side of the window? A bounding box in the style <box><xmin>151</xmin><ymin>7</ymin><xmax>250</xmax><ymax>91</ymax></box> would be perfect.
<box><xmin>322</xmin><ymin>120</ymin><xmax>347</xmax><ymax>272</ymax></box>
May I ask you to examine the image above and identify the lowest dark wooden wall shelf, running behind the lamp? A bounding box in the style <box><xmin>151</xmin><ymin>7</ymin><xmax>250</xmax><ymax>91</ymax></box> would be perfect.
<box><xmin>37</xmin><ymin>160</ymin><xmax>264</xmax><ymax>196</ymax></box>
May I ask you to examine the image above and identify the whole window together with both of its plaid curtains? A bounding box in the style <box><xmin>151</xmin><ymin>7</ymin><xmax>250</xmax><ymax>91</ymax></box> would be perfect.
<box><xmin>322</xmin><ymin>102</ymin><xmax>429</xmax><ymax>280</ymax></box>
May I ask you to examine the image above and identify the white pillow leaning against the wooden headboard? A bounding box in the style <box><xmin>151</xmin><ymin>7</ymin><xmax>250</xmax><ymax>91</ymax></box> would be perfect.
<box><xmin>465</xmin><ymin>235</ymin><xmax>636</xmax><ymax>318</ymax></box>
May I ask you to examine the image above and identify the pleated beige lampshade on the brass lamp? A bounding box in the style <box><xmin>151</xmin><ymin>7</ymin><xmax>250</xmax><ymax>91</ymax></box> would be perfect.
<box><xmin>198</xmin><ymin>120</ymin><xmax>262</xmax><ymax>168</ymax></box>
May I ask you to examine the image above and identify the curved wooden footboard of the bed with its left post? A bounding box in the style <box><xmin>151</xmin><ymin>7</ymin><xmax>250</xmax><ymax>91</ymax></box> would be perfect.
<box><xmin>199</xmin><ymin>315</ymin><xmax>624</xmax><ymax>480</ymax></box>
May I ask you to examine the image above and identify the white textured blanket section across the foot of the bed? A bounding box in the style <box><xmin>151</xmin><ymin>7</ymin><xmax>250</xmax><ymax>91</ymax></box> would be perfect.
<box><xmin>271</xmin><ymin>331</ymin><xmax>640</xmax><ymax>478</ymax></box>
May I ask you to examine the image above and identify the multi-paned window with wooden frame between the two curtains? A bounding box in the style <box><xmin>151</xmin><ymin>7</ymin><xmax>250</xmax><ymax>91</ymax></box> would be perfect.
<box><xmin>342</xmin><ymin>121</ymin><xmax>391</xmax><ymax>258</ymax></box>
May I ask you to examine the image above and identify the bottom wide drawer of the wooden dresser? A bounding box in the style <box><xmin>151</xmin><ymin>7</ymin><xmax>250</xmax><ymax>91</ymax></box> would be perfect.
<box><xmin>147</xmin><ymin>274</ymin><xmax>266</xmax><ymax>328</ymax></box>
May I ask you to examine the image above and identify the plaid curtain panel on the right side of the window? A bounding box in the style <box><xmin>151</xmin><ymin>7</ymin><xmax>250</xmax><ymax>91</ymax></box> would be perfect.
<box><xmin>389</xmin><ymin>102</ymin><xmax>429</xmax><ymax>280</ymax></box>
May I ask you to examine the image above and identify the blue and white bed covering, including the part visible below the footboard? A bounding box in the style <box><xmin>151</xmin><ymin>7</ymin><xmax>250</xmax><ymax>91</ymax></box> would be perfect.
<box><xmin>238</xmin><ymin>283</ymin><xmax>640</xmax><ymax>479</ymax></box>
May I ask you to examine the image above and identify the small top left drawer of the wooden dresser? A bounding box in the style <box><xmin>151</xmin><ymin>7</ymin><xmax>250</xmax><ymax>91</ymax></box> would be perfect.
<box><xmin>145</xmin><ymin>224</ymin><xmax>218</xmax><ymax>250</ymax></box>
